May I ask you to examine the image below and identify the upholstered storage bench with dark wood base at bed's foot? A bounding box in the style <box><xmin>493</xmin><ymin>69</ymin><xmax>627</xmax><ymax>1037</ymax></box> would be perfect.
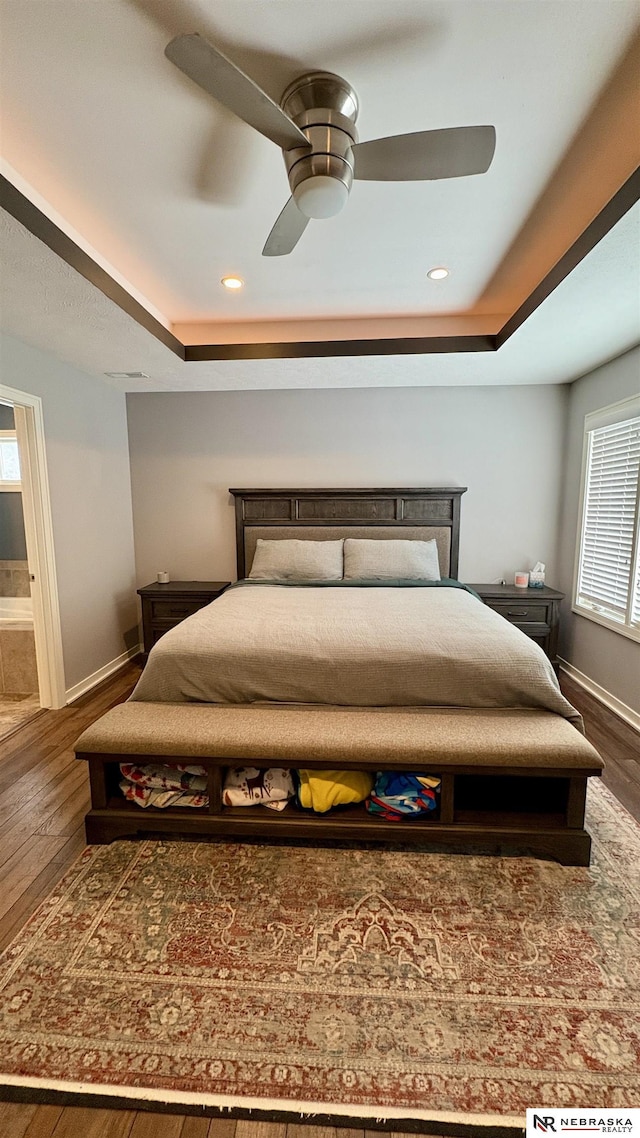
<box><xmin>75</xmin><ymin>702</ymin><xmax>602</xmax><ymax>865</ymax></box>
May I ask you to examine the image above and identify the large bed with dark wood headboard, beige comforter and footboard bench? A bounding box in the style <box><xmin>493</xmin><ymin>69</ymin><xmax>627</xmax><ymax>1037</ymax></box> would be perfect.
<box><xmin>76</xmin><ymin>487</ymin><xmax>601</xmax><ymax>864</ymax></box>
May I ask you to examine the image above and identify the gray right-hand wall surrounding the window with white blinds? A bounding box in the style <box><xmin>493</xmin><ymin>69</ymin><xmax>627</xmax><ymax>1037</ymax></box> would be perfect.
<box><xmin>558</xmin><ymin>348</ymin><xmax>640</xmax><ymax>712</ymax></box>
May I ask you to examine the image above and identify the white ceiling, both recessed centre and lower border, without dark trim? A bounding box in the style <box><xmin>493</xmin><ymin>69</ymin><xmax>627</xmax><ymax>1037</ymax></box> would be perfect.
<box><xmin>0</xmin><ymin>0</ymin><xmax>640</xmax><ymax>390</ymax></box>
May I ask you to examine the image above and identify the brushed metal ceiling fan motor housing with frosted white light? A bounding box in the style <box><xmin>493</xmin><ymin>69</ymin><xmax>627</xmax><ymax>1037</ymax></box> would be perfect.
<box><xmin>280</xmin><ymin>72</ymin><xmax>359</xmax><ymax>217</ymax></box>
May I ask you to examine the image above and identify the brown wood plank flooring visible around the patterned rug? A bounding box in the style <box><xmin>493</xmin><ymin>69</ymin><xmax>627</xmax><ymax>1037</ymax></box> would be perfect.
<box><xmin>0</xmin><ymin>663</ymin><xmax>640</xmax><ymax>1138</ymax></box>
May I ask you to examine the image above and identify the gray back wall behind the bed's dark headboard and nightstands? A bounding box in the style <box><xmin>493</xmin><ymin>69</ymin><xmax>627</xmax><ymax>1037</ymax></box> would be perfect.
<box><xmin>128</xmin><ymin>386</ymin><xmax>567</xmax><ymax>585</ymax></box>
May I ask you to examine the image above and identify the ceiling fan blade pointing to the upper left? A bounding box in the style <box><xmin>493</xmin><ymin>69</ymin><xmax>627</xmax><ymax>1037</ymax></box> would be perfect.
<box><xmin>164</xmin><ymin>32</ymin><xmax>309</xmax><ymax>150</ymax></box>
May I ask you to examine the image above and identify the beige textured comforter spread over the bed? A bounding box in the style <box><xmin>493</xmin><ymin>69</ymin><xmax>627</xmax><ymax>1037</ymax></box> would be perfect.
<box><xmin>131</xmin><ymin>585</ymin><xmax>581</xmax><ymax>726</ymax></box>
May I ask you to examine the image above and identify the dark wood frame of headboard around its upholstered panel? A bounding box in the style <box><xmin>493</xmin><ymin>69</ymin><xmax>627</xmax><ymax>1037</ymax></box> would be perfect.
<box><xmin>229</xmin><ymin>486</ymin><xmax>467</xmax><ymax>578</ymax></box>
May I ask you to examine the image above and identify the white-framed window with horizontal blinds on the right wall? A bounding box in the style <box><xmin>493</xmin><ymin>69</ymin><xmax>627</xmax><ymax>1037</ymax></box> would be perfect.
<box><xmin>574</xmin><ymin>398</ymin><xmax>640</xmax><ymax>641</ymax></box>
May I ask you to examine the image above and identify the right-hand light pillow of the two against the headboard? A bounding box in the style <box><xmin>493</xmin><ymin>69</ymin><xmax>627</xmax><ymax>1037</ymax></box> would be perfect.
<box><xmin>344</xmin><ymin>537</ymin><xmax>441</xmax><ymax>580</ymax></box>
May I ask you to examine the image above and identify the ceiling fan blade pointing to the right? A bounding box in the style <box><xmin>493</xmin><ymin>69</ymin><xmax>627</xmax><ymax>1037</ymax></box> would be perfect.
<box><xmin>353</xmin><ymin>126</ymin><xmax>495</xmax><ymax>182</ymax></box>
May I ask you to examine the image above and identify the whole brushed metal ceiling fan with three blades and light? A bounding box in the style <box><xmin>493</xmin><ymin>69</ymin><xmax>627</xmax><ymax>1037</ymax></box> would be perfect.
<box><xmin>165</xmin><ymin>33</ymin><xmax>495</xmax><ymax>257</ymax></box>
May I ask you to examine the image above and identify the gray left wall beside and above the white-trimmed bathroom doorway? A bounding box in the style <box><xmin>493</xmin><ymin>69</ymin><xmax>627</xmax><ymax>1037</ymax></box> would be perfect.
<box><xmin>0</xmin><ymin>336</ymin><xmax>138</xmax><ymax>690</ymax></box>
